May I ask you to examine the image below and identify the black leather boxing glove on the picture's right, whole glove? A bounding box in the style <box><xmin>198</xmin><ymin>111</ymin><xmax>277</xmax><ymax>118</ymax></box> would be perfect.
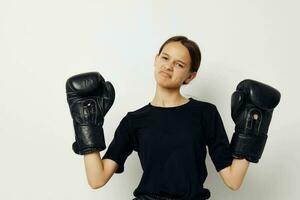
<box><xmin>230</xmin><ymin>79</ymin><xmax>281</xmax><ymax>163</ymax></box>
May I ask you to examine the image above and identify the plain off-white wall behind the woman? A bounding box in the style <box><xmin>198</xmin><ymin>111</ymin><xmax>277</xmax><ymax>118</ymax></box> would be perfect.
<box><xmin>0</xmin><ymin>0</ymin><xmax>300</xmax><ymax>200</ymax></box>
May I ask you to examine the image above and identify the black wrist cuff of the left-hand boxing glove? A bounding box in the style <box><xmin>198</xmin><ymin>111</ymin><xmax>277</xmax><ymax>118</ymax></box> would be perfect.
<box><xmin>72</xmin><ymin>125</ymin><xmax>106</xmax><ymax>155</ymax></box>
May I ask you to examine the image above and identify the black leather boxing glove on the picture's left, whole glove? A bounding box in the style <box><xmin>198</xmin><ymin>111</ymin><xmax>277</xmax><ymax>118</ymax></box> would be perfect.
<box><xmin>66</xmin><ymin>72</ymin><xmax>115</xmax><ymax>155</ymax></box>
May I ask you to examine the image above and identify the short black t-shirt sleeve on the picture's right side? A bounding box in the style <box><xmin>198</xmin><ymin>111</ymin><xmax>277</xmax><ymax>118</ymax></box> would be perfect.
<box><xmin>206</xmin><ymin>105</ymin><xmax>233</xmax><ymax>172</ymax></box>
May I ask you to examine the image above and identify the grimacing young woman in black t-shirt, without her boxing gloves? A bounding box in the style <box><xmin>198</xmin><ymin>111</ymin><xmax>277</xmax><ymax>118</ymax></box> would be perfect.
<box><xmin>84</xmin><ymin>36</ymin><xmax>249</xmax><ymax>200</ymax></box>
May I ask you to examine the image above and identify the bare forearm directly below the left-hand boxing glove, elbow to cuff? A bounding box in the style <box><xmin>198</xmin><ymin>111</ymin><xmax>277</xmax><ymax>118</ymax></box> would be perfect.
<box><xmin>84</xmin><ymin>152</ymin><xmax>104</xmax><ymax>189</ymax></box>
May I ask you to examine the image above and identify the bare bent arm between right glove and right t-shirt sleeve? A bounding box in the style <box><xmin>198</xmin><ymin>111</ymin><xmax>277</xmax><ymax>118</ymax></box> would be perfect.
<box><xmin>219</xmin><ymin>159</ymin><xmax>249</xmax><ymax>191</ymax></box>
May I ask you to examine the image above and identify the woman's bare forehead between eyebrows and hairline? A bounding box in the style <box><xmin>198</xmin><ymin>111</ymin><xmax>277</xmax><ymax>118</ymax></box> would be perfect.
<box><xmin>161</xmin><ymin>42</ymin><xmax>190</xmax><ymax>62</ymax></box>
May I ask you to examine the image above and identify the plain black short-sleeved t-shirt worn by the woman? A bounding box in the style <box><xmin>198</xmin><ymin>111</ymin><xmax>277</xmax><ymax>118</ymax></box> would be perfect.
<box><xmin>102</xmin><ymin>98</ymin><xmax>233</xmax><ymax>200</ymax></box>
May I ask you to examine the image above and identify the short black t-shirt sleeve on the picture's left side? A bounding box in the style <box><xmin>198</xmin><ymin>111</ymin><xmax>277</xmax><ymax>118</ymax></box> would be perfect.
<box><xmin>102</xmin><ymin>113</ymin><xmax>133</xmax><ymax>173</ymax></box>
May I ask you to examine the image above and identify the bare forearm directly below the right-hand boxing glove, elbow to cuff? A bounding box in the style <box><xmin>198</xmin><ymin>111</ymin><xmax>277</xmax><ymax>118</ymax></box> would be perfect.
<box><xmin>229</xmin><ymin>159</ymin><xmax>249</xmax><ymax>190</ymax></box>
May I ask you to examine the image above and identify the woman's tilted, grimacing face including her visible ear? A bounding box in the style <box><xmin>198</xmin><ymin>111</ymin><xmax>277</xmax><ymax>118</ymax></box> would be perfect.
<box><xmin>154</xmin><ymin>42</ymin><xmax>196</xmax><ymax>89</ymax></box>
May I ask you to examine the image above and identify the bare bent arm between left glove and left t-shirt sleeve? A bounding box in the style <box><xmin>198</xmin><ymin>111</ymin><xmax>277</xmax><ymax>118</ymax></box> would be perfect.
<box><xmin>84</xmin><ymin>152</ymin><xmax>118</xmax><ymax>189</ymax></box>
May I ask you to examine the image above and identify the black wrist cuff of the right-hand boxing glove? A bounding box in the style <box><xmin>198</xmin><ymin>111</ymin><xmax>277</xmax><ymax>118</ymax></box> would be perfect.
<box><xmin>230</xmin><ymin>133</ymin><xmax>268</xmax><ymax>163</ymax></box>
